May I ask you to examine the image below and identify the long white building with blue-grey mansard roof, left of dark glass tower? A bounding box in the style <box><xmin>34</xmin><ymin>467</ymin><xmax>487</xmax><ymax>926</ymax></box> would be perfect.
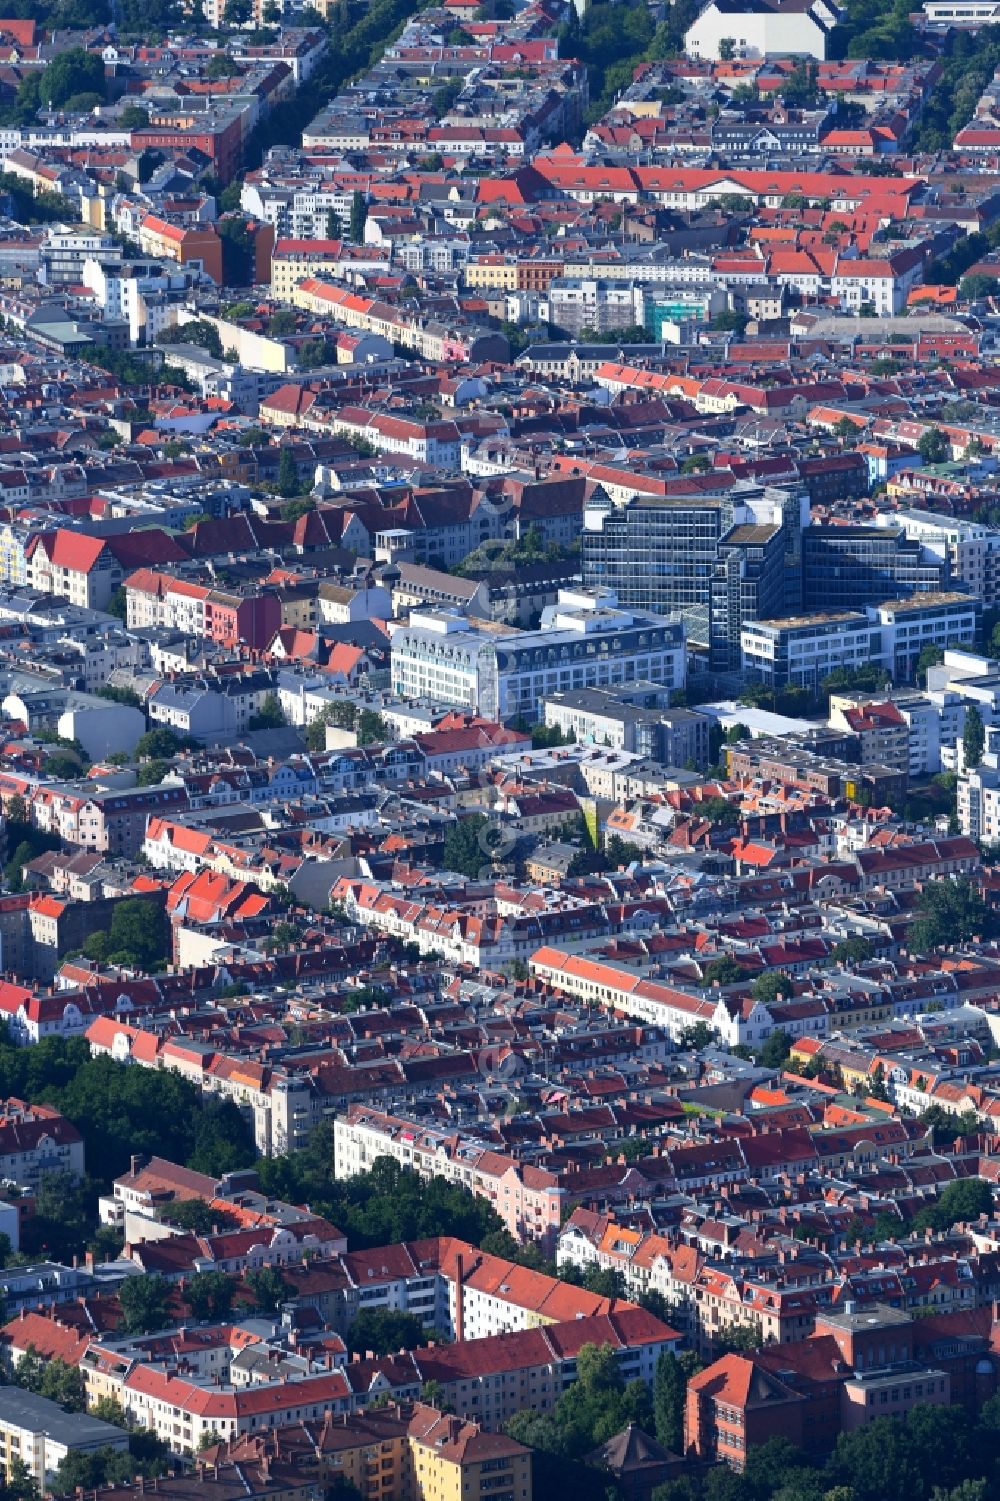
<box><xmin>390</xmin><ymin>590</ymin><xmax>685</xmax><ymax>723</ymax></box>
